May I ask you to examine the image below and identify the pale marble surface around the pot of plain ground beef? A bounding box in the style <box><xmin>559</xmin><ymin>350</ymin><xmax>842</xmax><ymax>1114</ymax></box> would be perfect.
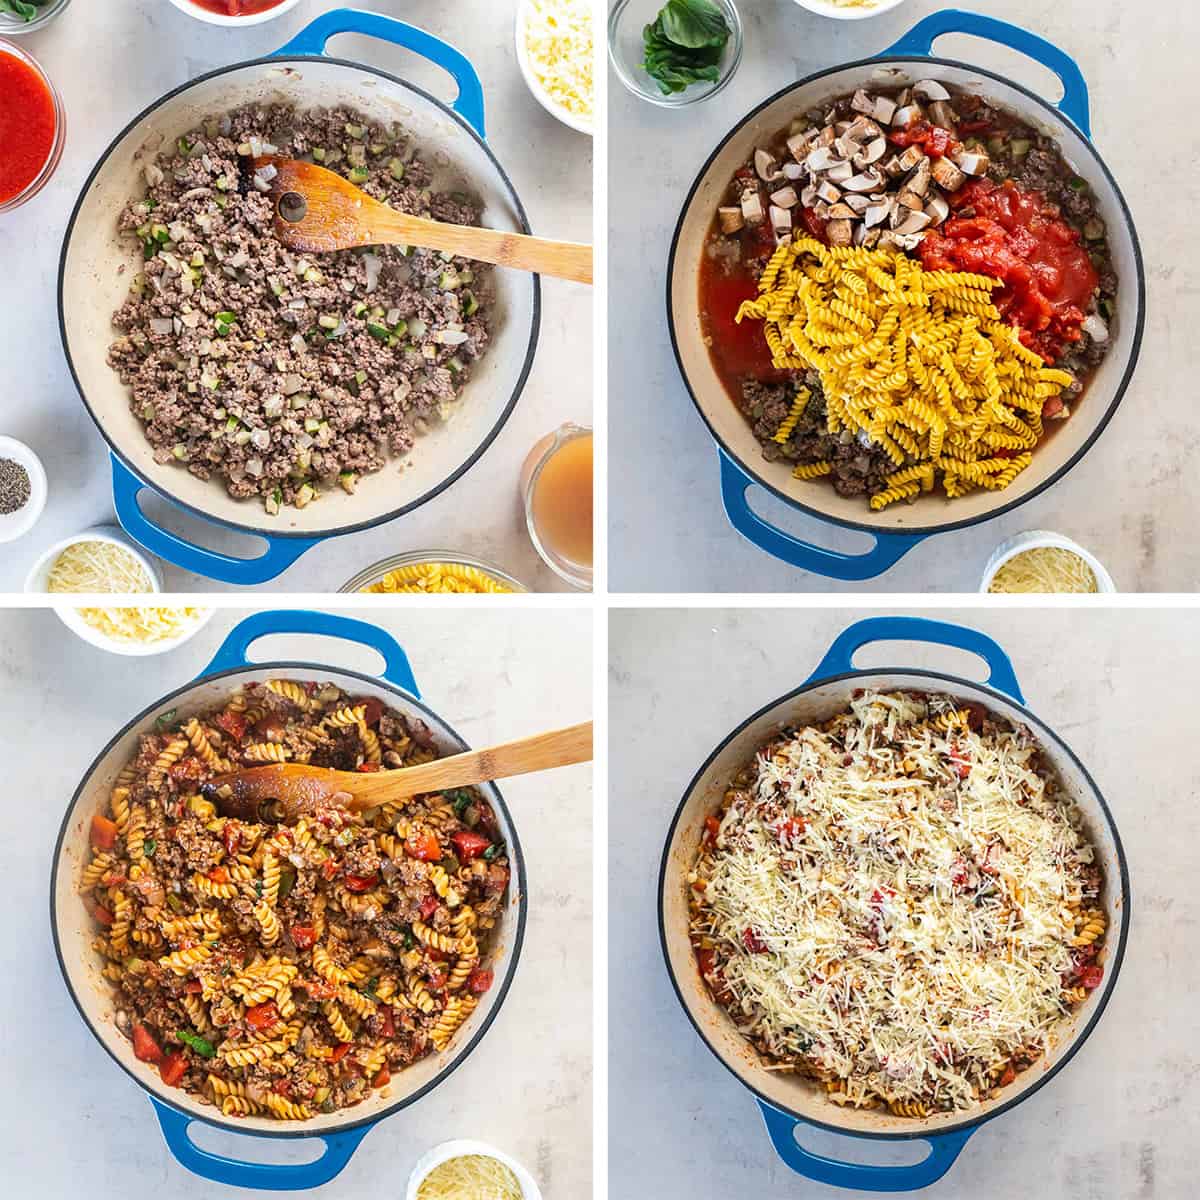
<box><xmin>0</xmin><ymin>0</ymin><xmax>593</xmax><ymax>592</ymax></box>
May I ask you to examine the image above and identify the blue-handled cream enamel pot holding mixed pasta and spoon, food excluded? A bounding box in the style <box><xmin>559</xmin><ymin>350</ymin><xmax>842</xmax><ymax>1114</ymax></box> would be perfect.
<box><xmin>50</xmin><ymin>611</ymin><xmax>526</xmax><ymax>1190</ymax></box>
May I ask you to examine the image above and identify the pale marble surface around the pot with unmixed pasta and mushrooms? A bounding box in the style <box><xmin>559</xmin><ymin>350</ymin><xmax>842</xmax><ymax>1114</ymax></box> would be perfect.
<box><xmin>608</xmin><ymin>0</ymin><xmax>1200</xmax><ymax>592</ymax></box>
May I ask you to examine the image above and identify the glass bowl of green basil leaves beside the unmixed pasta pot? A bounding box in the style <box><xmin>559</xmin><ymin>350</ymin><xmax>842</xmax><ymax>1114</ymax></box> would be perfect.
<box><xmin>608</xmin><ymin>0</ymin><xmax>742</xmax><ymax>108</ymax></box>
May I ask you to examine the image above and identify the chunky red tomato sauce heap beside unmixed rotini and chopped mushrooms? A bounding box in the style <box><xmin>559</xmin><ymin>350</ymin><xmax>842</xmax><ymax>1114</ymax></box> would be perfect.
<box><xmin>920</xmin><ymin>180</ymin><xmax>1099</xmax><ymax>362</ymax></box>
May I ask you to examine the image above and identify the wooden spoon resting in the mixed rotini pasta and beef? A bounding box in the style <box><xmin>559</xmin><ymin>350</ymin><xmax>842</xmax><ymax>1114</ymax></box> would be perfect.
<box><xmin>200</xmin><ymin>721</ymin><xmax>592</xmax><ymax>821</ymax></box>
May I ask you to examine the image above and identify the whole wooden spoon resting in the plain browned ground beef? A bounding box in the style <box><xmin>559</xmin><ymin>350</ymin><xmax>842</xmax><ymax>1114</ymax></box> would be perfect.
<box><xmin>254</xmin><ymin>155</ymin><xmax>592</xmax><ymax>283</ymax></box>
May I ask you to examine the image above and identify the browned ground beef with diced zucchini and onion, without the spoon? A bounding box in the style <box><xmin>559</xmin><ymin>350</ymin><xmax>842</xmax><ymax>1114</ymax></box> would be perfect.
<box><xmin>108</xmin><ymin>104</ymin><xmax>488</xmax><ymax>514</ymax></box>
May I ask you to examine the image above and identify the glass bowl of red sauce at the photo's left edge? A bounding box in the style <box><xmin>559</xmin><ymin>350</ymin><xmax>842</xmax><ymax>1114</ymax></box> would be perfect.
<box><xmin>0</xmin><ymin>38</ymin><xmax>66</xmax><ymax>212</ymax></box>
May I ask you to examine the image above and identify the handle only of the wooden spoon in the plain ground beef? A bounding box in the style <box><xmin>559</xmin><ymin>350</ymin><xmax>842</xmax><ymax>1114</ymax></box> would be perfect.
<box><xmin>364</xmin><ymin>204</ymin><xmax>592</xmax><ymax>283</ymax></box>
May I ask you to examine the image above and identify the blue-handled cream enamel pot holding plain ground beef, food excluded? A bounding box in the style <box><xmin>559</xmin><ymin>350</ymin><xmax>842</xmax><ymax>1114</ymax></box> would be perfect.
<box><xmin>59</xmin><ymin>10</ymin><xmax>540</xmax><ymax>583</ymax></box>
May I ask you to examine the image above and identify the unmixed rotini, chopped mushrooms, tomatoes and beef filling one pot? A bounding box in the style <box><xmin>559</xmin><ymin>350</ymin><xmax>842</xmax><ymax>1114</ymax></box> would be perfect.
<box><xmin>700</xmin><ymin>80</ymin><xmax>1117</xmax><ymax>506</ymax></box>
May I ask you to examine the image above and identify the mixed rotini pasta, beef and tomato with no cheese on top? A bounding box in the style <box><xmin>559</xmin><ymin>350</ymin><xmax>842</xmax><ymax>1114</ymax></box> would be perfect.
<box><xmin>80</xmin><ymin>679</ymin><xmax>510</xmax><ymax>1120</ymax></box>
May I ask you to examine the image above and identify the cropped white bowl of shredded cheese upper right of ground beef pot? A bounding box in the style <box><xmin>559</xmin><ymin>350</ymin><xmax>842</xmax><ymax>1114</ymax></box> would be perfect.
<box><xmin>516</xmin><ymin>0</ymin><xmax>595</xmax><ymax>134</ymax></box>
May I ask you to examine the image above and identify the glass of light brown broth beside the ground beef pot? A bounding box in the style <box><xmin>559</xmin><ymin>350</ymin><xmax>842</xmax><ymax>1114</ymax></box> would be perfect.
<box><xmin>521</xmin><ymin>425</ymin><xmax>592</xmax><ymax>589</ymax></box>
